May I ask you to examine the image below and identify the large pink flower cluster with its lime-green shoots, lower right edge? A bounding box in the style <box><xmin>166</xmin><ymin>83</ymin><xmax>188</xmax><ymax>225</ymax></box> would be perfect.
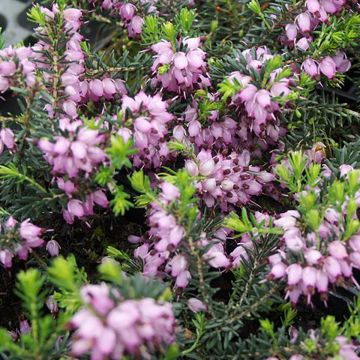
<box><xmin>269</xmin><ymin>167</ymin><xmax>360</xmax><ymax>303</ymax></box>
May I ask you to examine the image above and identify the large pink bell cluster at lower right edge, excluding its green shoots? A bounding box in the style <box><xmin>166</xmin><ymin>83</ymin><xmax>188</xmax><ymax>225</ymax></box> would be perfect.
<box><xmin>269</xmin><ymin>202</ymin><xmax>360</xmax><ymax>304</ymax></box>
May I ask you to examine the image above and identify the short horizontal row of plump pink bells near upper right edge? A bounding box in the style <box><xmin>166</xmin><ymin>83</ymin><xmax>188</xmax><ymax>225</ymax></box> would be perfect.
<box><xmin>302</xmin><ymin>51</ymin><xmax>351</xmax><ymax>80</ymax></box>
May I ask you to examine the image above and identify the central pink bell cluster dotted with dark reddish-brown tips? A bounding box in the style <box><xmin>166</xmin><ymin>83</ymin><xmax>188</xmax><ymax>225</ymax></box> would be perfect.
<box><xmin>185</xmin><ymin>150</ymin><xmax>274</xmax><ymax>211</ymax></box>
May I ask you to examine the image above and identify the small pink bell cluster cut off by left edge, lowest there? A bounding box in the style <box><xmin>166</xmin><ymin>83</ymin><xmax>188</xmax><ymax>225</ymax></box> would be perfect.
<box><xmin>0</xmin><ymin>216</ymin><xmax>44</xmax><ymax>268</ymax></box>
